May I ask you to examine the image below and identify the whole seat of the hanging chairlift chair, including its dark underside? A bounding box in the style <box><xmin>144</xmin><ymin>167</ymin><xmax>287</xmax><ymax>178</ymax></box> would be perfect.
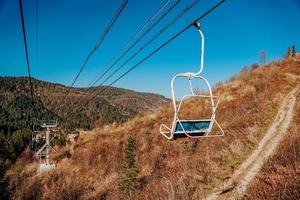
<box><xmin>174</xmin><ymin>120</ymin><xmax>211</xmax><ymax>138</ymax></box>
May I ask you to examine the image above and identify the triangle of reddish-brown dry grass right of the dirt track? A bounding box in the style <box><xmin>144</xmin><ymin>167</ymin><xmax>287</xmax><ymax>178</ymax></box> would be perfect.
<box><xmin>244</xmin><ymin>90</ymin><xmax>300</xmax><ymax>200</ymax></box>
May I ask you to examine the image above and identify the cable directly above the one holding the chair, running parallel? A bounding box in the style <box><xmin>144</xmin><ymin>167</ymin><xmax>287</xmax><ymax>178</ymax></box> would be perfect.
<box><xmin>92</xmin><ymin>0</ymin><xmax>200</xmax><ymax>90</ymax></box>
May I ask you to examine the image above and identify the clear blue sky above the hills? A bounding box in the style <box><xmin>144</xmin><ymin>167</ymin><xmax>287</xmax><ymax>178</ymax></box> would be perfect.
<box><xmin>0</xmin><ymin>0</ymin><xmax>300</xmax><ymax>96</ymax></box>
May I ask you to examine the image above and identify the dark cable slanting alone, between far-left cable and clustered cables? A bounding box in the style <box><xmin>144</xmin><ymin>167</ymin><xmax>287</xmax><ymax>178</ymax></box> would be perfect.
<box><xmin>65</xmin><ymin>0</ymin><xmax>128</xmax><ymax>97</ymax></box>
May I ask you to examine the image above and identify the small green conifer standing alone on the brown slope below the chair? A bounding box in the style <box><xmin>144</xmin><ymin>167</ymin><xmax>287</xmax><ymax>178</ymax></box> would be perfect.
<box><xmin>119</xmin><ymin>136</ymin><xmax>139</xmax><ymax>197</ymax></box>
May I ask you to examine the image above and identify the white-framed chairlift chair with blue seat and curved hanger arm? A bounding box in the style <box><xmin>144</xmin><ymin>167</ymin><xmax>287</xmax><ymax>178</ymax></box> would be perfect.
<box><xmin>160</xmin><ymin>22</ymin><xmax>224</xmax><ymax>140</ymax></box>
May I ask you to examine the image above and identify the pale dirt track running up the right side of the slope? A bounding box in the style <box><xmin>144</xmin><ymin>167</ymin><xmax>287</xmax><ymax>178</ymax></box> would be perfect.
<box><xmin>205</xmin><ymin>87</ymin><xmax>298</xmax><ymax>200</ymax></box>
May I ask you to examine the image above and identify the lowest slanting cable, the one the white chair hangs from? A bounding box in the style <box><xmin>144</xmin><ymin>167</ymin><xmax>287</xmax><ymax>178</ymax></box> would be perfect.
<box><xmin>87</xmin><ymin>0</ymin><xmax>225</xmax><ymax>103</ymax></box>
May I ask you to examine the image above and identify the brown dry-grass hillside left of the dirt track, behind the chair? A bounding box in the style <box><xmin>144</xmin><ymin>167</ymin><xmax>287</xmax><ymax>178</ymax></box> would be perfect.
<box><xmin>7</xmin><ymin>61</ymin><xmax>300</xmax><ymax>199</ymax></box>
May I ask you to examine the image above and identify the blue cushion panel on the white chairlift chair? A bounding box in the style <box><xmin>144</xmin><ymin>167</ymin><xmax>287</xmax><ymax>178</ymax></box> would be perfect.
<box><xmin>175</xmin><ymin>120</ymin><xmax>211</xmax><ymax>133</ymax></box>
